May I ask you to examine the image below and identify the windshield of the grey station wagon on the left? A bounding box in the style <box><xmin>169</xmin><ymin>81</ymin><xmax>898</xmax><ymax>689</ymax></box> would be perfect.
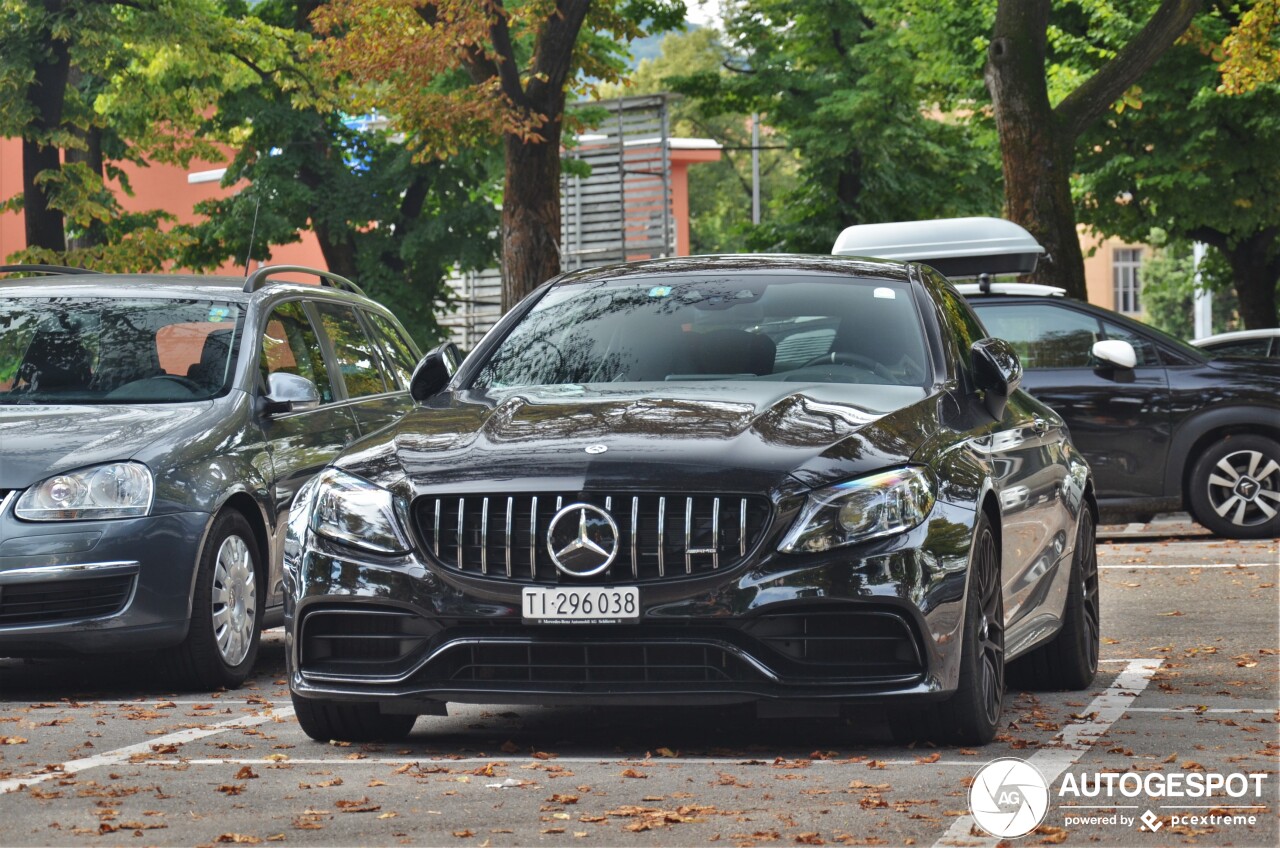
<box><xmin>0</xmin><ymin>297</ymin><xmax>241</xmax><ymax>404</ymax></box>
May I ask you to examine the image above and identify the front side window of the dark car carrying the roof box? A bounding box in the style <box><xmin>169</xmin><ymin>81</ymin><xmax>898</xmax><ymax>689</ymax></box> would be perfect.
<box><xmin>974</xmin><ymin>304</ymin><xmax>1102</xmax><ymax>368</ymax></box>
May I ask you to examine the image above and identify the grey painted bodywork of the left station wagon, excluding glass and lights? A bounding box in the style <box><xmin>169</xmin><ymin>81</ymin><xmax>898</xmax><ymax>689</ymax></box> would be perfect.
<box><xmin>0</xmin><ymin>274</ymin><xmax>412</xmax><ymax>657</ymax></box>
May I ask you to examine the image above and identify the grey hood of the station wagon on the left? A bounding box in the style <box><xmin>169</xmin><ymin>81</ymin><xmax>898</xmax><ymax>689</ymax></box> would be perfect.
<box><xmin>0</xmin><ymin>401</ymin><xmax>212</xmax><ymax>489</ymax></box>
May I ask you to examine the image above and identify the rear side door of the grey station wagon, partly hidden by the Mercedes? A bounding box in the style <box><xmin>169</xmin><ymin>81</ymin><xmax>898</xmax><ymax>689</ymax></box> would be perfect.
<box><xmin>315</xmin><ymin>300</ymin><xmax>413</xmax><ymax>434</ymax></box>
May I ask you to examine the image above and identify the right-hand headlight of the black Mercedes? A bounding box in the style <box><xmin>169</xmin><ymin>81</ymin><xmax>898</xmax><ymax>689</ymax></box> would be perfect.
<box><xmin>778</xmin><ymin>468</ymin><xmax>934</xmax><ymax>553</ymax></box>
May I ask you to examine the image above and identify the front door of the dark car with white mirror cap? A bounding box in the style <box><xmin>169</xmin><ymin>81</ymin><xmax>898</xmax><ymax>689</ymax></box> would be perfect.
<box><xmin>972</xmin><ymin>301</ymin><xmax>1171</xmax><ymax>498</ymax></box>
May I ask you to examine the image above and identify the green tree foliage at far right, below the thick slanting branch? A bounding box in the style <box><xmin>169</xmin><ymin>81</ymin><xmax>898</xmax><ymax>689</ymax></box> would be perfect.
<box><xmin>1079</xmin><ymin>12</ymin><xmax>1280</xmax><ymax>329</ymax></box>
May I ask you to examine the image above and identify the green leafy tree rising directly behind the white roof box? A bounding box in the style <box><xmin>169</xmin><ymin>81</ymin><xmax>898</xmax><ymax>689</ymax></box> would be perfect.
<box><xmin>672</xmin><ymin>0</ymin><xmax>1000</xmax><ymax>252</ymax></box>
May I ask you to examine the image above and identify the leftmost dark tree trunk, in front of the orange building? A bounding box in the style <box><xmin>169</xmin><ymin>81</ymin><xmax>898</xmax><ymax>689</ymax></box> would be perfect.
<box><xmin>22</xmin><ymin>0</ymin><xmax>70</xmax><ymax>252</ymax></box>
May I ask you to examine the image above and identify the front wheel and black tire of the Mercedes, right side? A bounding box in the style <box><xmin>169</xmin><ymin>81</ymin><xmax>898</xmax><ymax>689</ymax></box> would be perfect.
<box><xmin>890</xmin><ymin>514</ymin><xmax>1005</xmax><ymax>746</ymax></box>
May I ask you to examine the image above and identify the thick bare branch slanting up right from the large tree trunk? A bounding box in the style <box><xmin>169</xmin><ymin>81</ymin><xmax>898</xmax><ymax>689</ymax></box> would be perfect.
<box><xmin>1053</xmin><ymin>0</ymin><xmax>1202</xmax><ymax>140</ymax></box>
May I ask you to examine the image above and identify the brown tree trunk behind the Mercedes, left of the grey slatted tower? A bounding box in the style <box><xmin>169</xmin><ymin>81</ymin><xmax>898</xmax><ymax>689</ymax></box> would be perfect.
<box><xmin>502</xmin><ymin>117</ymin><xmax>563</xmax><ymax>313</ymax></box>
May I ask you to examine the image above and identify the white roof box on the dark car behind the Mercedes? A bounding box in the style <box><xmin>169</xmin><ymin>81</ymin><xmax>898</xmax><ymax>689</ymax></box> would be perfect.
<box><xmin>831</xmin><ymin>218</ymin><xmax>1044</xmax><ymax>277</ymax></box>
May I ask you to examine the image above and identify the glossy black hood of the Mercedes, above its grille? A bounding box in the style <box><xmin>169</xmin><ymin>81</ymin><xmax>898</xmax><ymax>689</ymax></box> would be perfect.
<box><xmin>339</xmin><ymin>382</ymin><xmax>938</xmax><ymax>493</ymax></box>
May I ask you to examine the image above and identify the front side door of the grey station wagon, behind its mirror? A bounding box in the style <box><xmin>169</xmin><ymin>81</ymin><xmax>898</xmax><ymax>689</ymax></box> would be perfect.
<box><xmin>259</xmin><ymin>300</ymin><xmax>360</xmax><ymax>605</ymax></box>
